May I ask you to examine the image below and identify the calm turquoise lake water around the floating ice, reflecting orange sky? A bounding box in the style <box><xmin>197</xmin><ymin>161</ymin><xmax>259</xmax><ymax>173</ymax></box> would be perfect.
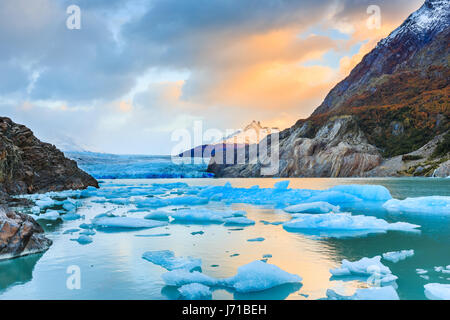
<box><xmin>0</xmin><ymin>178</ymin><xmax>450</xmax><ymax>300</ymax></box>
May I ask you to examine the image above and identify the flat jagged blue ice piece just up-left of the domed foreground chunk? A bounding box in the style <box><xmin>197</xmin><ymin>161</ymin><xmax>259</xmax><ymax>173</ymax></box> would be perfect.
<box><xmin>142</xmin><ymin>250</ymin><xmax>202</xmax><ymax>271</ymax></box>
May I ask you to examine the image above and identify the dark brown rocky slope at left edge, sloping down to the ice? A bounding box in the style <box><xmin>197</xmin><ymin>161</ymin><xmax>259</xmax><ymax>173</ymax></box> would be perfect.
<box><xmin>0</xmin><ymin>117</ymin><xmax>98</xmax><ymax>200</ymax></box>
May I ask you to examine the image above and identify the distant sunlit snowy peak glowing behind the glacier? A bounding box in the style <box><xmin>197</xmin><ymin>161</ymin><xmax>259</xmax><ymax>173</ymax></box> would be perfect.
<box><xmin>179</xmin><ymin>120</ymin><xmax>279</xmax><ymax>158</ymax></box>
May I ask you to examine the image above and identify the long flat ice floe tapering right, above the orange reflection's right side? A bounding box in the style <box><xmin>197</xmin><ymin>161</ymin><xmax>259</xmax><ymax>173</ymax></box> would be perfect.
<box><xmin>283</xmin><ymin>213</ymin><xmax>420</xmax><ymax>233</ymax></box>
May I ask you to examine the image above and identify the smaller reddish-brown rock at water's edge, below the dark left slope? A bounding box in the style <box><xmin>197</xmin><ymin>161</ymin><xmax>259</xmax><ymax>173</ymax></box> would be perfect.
<box><xmin>0</xmin><ymin>206</ymin><xmax>52</xmax><ymax>260</ymax></box>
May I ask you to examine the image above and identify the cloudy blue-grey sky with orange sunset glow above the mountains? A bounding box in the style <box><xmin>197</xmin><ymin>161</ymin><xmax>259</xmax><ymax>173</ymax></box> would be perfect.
<box><xmin>0</xmin><ymin>0</ymin><xmax>423</xmax><ymax>154</ymax></box>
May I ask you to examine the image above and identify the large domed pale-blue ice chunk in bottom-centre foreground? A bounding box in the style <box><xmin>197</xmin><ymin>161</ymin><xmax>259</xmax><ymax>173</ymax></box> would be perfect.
<box><xmin>220</xmin><ymin>260</ymin><xmax>302</xmax><ymax>293</ymax></box>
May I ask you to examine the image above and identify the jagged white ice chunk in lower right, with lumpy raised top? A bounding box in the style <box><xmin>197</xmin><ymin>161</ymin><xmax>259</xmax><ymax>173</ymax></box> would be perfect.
<box><xmin>330</xmin><ymin>256</ymin><xmax>397</xmax><ymax>283</ymax></box>
